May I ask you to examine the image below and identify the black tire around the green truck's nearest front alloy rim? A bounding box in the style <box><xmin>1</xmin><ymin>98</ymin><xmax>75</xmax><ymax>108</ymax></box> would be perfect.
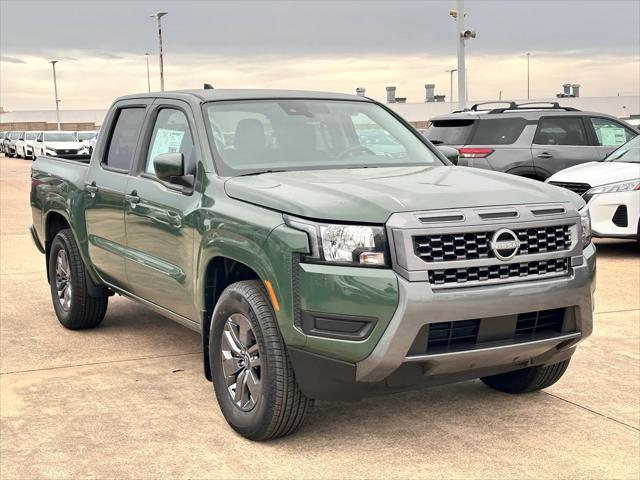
<box><xmin>209</xmin><ymin>286</ymin><xmax>274</xmax><ymax>436</ymax></box>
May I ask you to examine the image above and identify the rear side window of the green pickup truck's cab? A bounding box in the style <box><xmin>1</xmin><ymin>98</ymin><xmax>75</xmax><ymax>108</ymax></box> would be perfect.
<box><xmin>104</xmin><ymin>107</ymin><xmax>146</xmax><ymax>171</ymax></box>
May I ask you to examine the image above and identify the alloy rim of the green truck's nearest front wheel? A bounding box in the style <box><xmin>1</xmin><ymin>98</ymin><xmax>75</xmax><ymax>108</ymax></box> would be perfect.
<box><xmin>221</xmin><ymin>313</ymin><xmax>262</xmax><ymax>412</ymax></box>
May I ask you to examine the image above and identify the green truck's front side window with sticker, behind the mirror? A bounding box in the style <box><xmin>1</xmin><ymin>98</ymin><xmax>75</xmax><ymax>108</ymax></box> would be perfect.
<box><xmin>145</xmin><ymin>108</ymin><xmax>193</xmax><ymax>175</ymax></box>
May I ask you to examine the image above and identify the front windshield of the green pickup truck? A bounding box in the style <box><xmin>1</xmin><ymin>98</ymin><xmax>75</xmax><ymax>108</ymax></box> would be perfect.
<box><xmin>206</xmin><ymin>99</ymin><xmax>442</xmax><ymax>175</ymax></box>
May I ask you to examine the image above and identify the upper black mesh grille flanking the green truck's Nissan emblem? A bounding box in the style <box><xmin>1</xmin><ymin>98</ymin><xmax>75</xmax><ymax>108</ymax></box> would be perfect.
<box><xmin>413</xmin><ymin>225</ymin><xmax>571</xmax><ymax>263</ymax></box>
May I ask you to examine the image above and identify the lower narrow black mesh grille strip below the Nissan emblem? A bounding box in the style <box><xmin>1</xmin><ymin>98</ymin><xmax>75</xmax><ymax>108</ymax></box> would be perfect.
<box><xmin>429</xmin><ymin>258</ymin><xmax>569</xmax><ymax>286</ymax></box>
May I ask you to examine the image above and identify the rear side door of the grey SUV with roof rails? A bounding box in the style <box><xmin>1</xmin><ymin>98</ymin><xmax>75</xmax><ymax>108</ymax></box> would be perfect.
<box><xmin>531</xmin><ymin>116</ymin><xmax>601</xmax><ymax>179</ymax></box>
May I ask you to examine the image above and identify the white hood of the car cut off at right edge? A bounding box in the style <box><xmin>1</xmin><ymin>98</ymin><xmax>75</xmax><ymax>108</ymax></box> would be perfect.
<box><xmin>548</xmin><ymin>162</ymin><xmax>640</xmax><ymax>187</ymax></box>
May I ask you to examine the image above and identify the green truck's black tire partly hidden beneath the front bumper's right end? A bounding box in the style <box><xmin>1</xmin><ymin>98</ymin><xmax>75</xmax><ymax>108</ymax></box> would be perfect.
<box><xmin>480</xmin><ymin>359</ymin><xmax>569</xmax><ymax>393</ymax></box>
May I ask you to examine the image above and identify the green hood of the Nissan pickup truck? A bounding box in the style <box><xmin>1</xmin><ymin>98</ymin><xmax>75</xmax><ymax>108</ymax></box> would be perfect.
<box><xmin>225</xmin><ymin>166</ymin><xmax>584</xmax><ymax>224</ymax></box>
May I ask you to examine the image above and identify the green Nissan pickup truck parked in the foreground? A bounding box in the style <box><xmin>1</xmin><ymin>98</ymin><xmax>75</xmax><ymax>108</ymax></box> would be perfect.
<box><xmin>31</xmin><ymin>89</ymin><xmax>595</xmax><ymax>440</ymax></box>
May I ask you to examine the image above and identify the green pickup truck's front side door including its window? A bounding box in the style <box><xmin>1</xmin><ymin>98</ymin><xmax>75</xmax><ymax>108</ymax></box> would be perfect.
<box><xmin>125</xmin><ymin>100</ymin><xmax>199</xmax><ymax>321</ymax></box>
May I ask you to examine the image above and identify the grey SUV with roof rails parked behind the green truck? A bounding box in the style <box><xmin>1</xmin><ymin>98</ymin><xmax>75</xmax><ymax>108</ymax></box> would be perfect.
<box><xmin>425</xmin><ymin>102</ymin><xmax>639</xmax><ymax>180</ymax></box>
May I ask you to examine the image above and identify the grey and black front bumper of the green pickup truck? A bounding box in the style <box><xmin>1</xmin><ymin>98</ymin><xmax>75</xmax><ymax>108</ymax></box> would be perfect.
<box><xmin>290</xmin><ymin>244</ymin><xmax>596</xmax><ymax>400</ymax></box>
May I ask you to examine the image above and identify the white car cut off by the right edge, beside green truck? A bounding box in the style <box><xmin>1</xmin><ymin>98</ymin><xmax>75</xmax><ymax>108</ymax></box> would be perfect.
<box><xmin>547</xmin><ymin>136</ymin><xmax>640</xmax><ymax>242</ymax></box>
